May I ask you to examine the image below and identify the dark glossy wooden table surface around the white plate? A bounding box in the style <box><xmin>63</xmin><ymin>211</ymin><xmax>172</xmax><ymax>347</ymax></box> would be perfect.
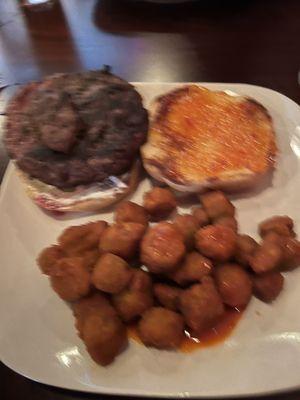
<box><xmin>0</xmin><ymin>0</ymin><xmax>300</xmax><ymax>400</ymax></box>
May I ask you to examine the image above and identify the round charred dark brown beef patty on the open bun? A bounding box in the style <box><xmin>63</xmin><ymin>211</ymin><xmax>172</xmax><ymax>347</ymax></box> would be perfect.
<box><xmin>5</xmin><ymin>71</ymin><xmax>148</xmax><ymax>189</ymax></box>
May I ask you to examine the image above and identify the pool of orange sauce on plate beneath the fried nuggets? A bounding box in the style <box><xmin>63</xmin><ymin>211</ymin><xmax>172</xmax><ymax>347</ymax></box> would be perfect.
<box><xmin>127</xmin><ymin>308</ymin><xmax>243</xmax><ymax>353</ymax></box>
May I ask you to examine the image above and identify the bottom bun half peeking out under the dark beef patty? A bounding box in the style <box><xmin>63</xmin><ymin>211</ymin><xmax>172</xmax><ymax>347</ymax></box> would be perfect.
<box><xmin>17</xmin><ymin>161</ymin><xmax>141</xmax><ymax>212</ymax></box>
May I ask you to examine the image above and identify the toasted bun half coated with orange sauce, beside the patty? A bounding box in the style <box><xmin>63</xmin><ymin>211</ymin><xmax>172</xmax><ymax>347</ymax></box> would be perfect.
<box><xmin>142</xmin><ymin>85</ymin><xmax>277</xmax><ymax>191</ymax></box>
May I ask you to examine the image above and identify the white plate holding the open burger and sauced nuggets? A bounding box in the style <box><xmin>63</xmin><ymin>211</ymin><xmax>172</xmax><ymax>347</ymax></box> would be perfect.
<box><xmin>0</xmin><ymin>83</ymin><xmax>300</xmax><ymax>397</ymax></box>
